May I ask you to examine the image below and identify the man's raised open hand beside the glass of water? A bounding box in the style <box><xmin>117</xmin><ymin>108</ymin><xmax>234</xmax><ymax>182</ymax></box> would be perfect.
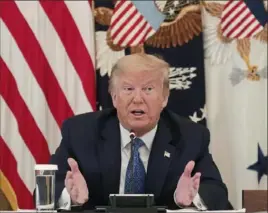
<box><xmin>65</xmin><ymin>158</ymin><xmax>88</xmax><ymax>205</ymax></box>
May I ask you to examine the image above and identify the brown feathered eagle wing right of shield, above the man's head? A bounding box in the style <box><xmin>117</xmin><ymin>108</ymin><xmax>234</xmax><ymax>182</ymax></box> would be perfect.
<box><xmin>145</xmin><ymin>4</ymin><xmax>202</xmax><ymax>48</ymax></box>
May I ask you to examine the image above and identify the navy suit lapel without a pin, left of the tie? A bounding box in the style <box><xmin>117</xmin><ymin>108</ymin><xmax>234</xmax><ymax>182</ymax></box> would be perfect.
<box><xmin>98</xmin><ymin>115</ymin><xmax>121</xmax><ymax>199</ymax></box>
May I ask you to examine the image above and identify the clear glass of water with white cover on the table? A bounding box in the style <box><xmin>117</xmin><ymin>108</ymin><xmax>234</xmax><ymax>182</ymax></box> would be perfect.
<box><xmin>34</xmin><ymin>164</ymin><xmax>58</xmax><ymax>210</ymax></box>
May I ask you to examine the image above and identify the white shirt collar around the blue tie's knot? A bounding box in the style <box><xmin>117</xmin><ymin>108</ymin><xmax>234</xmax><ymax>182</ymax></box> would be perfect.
<box><xmin>120</xmin><ymin>123</ymin><xmax>157</xmax><ymax>150</ymax></box>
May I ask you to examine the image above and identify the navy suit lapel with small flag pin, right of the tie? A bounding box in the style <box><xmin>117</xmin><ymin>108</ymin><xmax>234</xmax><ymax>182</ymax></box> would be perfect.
<box><xmin>146</xmin><ymin>119</ymin><xmax>176</xmax><ymax>198</ymax></box>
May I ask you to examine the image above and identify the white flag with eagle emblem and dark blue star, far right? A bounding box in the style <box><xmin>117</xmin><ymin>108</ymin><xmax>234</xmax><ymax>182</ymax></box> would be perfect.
<box><xmin>203</xmin><ymin>0</ymin><xmax>268</xmax><ymax>209</ymax></box>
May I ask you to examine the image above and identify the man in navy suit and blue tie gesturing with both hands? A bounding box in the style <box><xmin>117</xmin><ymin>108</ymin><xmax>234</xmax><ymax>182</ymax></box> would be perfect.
<box><xmin>51</xmin><ymin>54</ymin><xmax>228</xmax><ymax>210</ymax></box>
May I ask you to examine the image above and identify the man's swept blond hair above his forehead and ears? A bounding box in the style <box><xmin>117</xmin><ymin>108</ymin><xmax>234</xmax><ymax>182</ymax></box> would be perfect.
<box><xmin>109</xmin><ymin>53</ymin><xmax>169</xmax><ymax>93</ymax></box>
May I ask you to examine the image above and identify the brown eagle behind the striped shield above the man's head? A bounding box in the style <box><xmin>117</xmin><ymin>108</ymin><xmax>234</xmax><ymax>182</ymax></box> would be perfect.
<box><xmin>94</xmin><ymin>0</ymin><xmax>202</xmax><ymax>52</ymax></box>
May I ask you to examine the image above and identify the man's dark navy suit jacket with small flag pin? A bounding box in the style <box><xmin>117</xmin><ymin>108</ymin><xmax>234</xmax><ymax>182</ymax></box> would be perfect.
<box><xmin>50</xmin><ymin>109</ymin><xmax>228</xmax><ymax>209</ymax></box>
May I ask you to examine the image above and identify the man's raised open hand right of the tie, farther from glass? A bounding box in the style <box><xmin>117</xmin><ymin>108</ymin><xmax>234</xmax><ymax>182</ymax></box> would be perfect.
<box><xmin>175</xmin><ymin>161</ymin><xmax>201</xmax><ymax>207</ymax></box>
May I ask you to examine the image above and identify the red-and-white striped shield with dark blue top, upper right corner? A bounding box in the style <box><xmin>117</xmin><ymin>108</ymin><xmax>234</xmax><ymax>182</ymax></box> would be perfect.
<box><xmin>221</xmin><ymin>0</ymin><xmax>266</xmax><ymax>39</ymax></box>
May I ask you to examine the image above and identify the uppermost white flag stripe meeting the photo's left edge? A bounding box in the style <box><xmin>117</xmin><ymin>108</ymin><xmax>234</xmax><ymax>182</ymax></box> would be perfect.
<box><xmin>0</xmin><ymin>21</ymin><xmax>61</xmax><ymax>153</ymax></box>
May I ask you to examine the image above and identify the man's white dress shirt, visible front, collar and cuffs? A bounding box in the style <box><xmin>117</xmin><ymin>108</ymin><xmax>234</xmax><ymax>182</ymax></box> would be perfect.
<box><xmin>58</xmin><ymin>124</ymin><xmax>207</xmax><ymax>210</ymax></box>
